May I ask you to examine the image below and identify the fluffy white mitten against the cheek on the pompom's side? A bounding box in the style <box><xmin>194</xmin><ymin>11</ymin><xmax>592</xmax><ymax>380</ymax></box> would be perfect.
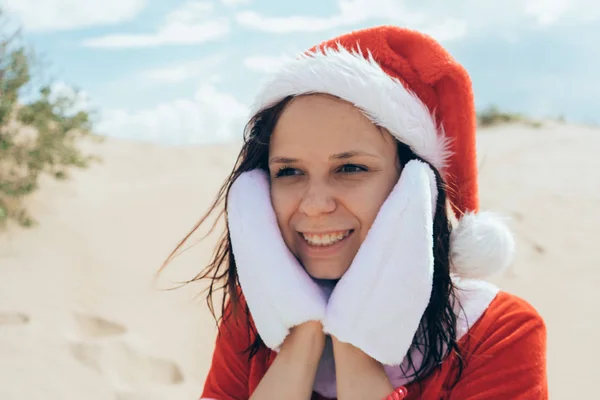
<box><xmin>323</xmin><ymin>161</ymin><xmax>437</xmax><ymax>365</ymax></box>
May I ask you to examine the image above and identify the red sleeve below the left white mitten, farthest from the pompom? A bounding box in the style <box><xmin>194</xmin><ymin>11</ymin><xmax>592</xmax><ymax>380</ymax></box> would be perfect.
<box><xmin>201</xmin><ymin>307</ymin><xmax>250</xmax><ymax>400</ymax></box>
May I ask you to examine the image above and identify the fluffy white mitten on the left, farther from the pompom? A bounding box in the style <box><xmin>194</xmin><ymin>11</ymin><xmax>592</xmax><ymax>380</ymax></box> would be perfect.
<box><xmin>227</xmin><ymin>169</ymin><xmax>327</xmax><ymax>351</ymax></box>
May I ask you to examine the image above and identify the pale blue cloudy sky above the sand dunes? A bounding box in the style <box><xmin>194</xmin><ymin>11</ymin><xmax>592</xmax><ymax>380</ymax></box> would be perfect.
<box><xmin>0</xmin><ymin>0</ymin><xmax>600</xmax><ymax>145</ymax></box>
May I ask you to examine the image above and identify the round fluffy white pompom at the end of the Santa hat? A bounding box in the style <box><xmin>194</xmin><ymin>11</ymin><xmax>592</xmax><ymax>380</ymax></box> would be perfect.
<box><xmin>450</xmin><ymin>212</ymin><xmax>515</xmax><ymax>279</ymax></box>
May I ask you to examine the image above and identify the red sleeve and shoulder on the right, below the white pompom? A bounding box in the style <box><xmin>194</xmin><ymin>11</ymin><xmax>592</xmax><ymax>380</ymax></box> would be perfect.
<box><xmin>448</xmin><ymin>293</ymin><xmax>548</xmax><ymax>400</ymax></box>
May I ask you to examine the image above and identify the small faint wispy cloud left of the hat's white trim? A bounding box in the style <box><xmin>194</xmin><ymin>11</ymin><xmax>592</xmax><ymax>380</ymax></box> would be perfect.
<box><xmin>139</xmin><ymin>54</ymin><xmax>225</xmax><ymax>83</ymax></box>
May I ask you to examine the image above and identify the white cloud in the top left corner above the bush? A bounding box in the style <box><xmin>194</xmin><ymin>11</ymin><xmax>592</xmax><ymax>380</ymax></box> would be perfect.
<box><xmin>2</xmin><ymin>0</ymin><xmax>147</xmax><ymax>32</ymax></box>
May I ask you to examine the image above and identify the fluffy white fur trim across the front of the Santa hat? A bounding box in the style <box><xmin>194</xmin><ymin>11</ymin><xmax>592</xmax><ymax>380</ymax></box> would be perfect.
<box><xmin>251</xmin><ymin>45</ymin><xmax>450</xmax><ymax>171</ymax></box>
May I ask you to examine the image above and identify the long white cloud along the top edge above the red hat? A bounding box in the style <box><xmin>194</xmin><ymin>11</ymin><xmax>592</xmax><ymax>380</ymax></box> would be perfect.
<box><xmin>236</xmin><ymin>0</ymin><xmax>600</xmax><ymax>41</ymax></box>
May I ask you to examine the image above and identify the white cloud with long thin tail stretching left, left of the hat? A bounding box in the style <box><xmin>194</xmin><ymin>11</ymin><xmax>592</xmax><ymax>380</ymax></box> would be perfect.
<box><xmin>83</xmin><ymin>1</ymin><xmax>230</xmax><ymax>48</ymax></box>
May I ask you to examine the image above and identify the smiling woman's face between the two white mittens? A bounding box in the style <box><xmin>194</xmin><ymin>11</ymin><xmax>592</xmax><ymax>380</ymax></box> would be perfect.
<box><xmin>269</xmin><ymin>95</ymin><xmax>401</xmax><ymax>279</ymax></box>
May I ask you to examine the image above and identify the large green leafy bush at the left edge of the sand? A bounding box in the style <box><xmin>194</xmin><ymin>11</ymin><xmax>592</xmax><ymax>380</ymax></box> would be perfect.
<box><xmin>0</xmin><ymin>10</ymin><xmax>97</xmax><ymax>226</ymax></box>
